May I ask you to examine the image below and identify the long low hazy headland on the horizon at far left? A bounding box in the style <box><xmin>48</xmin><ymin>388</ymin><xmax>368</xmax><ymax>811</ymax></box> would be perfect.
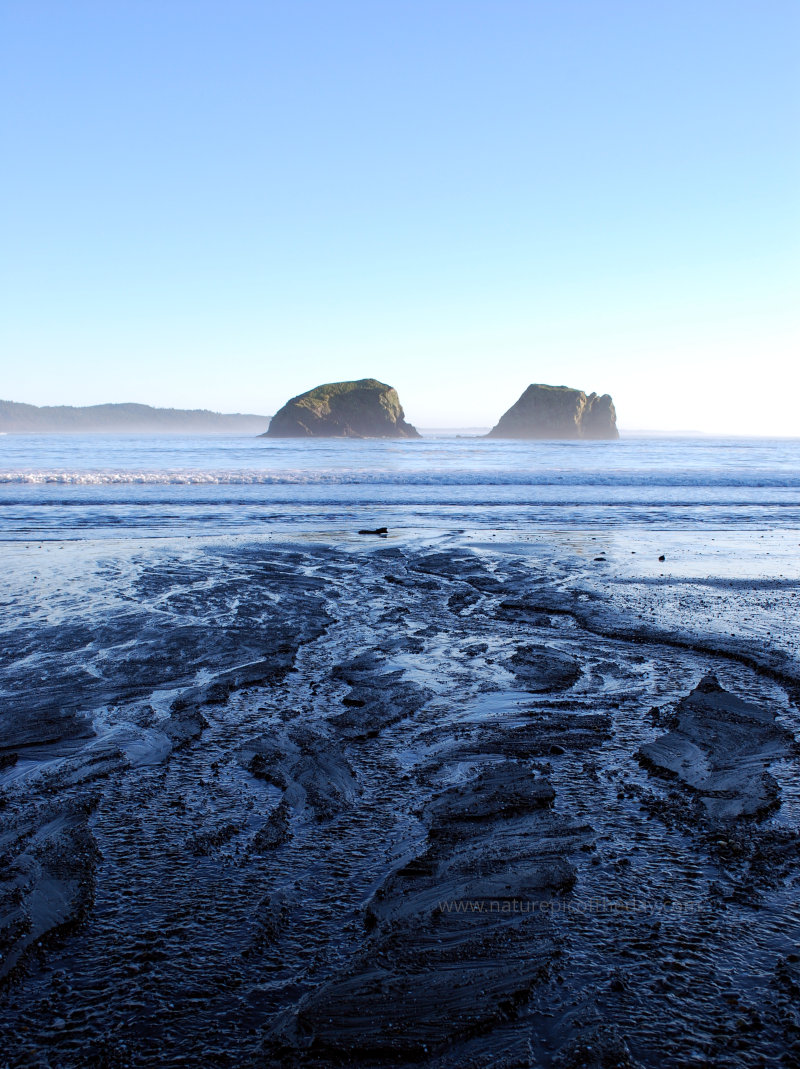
<box><xmin>0</xmin><ymin>401</ymin><xmax>270</xmax><ymax>434</ymax></box>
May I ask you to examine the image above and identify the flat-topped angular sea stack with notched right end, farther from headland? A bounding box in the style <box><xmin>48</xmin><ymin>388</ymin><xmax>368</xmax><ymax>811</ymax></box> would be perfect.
<box><xmin>488</xmin><ymin>383</ymin><xmax>619</xmax><ymax>438</ymax></box>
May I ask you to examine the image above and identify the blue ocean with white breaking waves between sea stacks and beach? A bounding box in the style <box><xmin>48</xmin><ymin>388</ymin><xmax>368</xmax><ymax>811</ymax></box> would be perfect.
<box><xmin>0</xmin><ymin>433</ymin><xmax>800</xmax><ymax>540</ymax></box>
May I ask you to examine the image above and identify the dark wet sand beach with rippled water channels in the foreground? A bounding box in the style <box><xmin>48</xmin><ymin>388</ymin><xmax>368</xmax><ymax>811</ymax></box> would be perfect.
<box><xmin>0</xmin><ymin>530</ymin><xmax>800</xmax><ymax>1069</ymax></box>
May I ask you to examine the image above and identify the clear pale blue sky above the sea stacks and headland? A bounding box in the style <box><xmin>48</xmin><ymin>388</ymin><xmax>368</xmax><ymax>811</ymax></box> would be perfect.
<box><xmin>0</xmin><ymin>0</ymin><xmax>800</xmax><ymax>435</ymax></box>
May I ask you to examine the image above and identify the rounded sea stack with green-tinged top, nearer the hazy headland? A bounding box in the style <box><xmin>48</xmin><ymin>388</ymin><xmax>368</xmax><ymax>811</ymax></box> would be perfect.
<box><xmin>262</xmin><ymin>378</ymin><xmax>419</xmax><ymax>438</ymax></box>
